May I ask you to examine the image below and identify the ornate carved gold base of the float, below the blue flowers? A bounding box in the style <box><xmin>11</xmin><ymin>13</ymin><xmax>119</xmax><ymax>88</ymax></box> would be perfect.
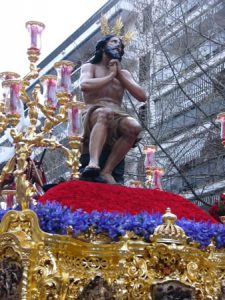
<box><xmin>0</xmin><ymin>210</ymin><xmax>225</xmax><ymax>300</ymax></box>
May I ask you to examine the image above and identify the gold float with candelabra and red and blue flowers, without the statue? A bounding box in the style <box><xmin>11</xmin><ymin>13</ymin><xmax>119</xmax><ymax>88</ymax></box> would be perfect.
<box><xmin>0</xmin><ymin>21</ymin><xmax>225</xmax><ymax>300</ymax></box>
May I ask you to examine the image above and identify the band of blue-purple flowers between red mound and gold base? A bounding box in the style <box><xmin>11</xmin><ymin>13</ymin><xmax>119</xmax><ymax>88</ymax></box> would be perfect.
<box><xmin>0</xmin><ymin>201</ymin><xmax>225</xmax><ymax>248</ymax></box>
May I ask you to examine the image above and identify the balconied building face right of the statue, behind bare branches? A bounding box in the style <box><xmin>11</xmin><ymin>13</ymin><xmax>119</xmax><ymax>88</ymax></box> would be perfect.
<box><xmin>137</xmin><ymin>0</ymin><xmax>225</xmax><ymax>205</ymax></box>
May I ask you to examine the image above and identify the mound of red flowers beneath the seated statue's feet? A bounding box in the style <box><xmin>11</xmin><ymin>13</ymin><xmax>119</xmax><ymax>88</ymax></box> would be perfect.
<box><xmin>39</xmin><ymin>181</ymin><xmax>217</xmax><ymax>223</ymax></box>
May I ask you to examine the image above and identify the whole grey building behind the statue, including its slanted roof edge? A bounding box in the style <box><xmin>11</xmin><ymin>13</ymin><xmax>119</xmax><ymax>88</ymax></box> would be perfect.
<box><xmin>2</xmin><ymin>0</ymin><xmax>225</xmax><ymax>209</ymax></box>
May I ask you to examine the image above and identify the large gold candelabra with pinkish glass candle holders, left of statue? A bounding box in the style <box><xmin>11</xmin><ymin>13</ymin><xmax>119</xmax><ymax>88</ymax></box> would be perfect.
<box><xmin>0</xmin><ymin>21</ymin><xmax>84</xmax><ymax>209</ymax></box>
